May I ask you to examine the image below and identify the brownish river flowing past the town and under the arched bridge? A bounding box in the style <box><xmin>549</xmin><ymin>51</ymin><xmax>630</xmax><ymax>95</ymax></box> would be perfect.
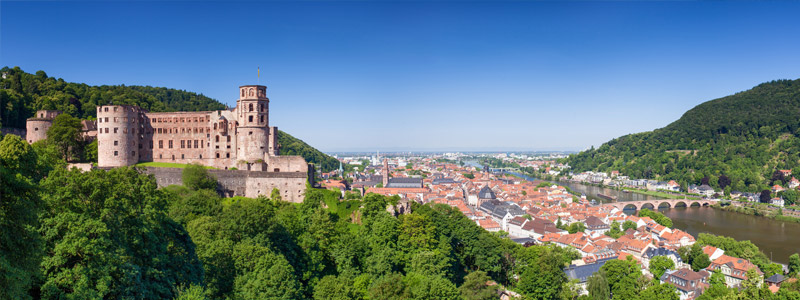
<box><xmin>462</xmin><ymin>163</ymin><xmax>800</xmax><ymax>264</ymax></box>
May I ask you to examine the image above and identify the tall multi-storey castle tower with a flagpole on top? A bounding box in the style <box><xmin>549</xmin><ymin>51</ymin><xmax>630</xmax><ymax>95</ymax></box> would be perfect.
<box><xmin>236</xmin><ymin>85</ymin><xmax>270</xmax><ymax>163</ymax></box>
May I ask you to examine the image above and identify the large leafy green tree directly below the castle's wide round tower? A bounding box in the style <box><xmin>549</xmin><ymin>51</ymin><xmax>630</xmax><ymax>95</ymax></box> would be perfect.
<box><xmin>39</xmin><ymin>168</ymin><xmax>203</xmax><ymax>299</ymax></box>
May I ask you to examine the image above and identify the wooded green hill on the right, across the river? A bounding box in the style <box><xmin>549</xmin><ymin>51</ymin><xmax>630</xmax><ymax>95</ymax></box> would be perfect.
<box><xmin>564</xmin><ymin>79</ymin><xmax>800</xmax><ymax>191</ymax></box>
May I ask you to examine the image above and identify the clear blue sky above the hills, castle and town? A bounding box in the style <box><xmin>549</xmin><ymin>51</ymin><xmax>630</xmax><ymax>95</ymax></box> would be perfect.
<box><xmin>0</xmin><ymin>1</ymin><xmax>800</xmax><ymax>151</ymax></box>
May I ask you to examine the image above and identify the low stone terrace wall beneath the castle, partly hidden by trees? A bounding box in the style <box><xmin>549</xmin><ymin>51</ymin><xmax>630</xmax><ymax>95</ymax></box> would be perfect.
<box><xmin>144</xmin><ymin>167</ymin><xmax>308</xmax><ymax>203</ymax></box>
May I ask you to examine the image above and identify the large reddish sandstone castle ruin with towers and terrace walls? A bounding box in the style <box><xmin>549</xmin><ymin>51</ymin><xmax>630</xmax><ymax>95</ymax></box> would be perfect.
<box><xmin>26</xmin><ymin>85</ymin><xmax>313</xmax><ymax>202</ymax></box>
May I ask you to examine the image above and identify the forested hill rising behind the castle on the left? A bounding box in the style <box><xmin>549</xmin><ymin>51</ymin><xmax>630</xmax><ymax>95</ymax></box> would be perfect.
<box><xmin>0</xmin><ymin>67</ymin><xmax>339</xmax><ymax>172</ymax></box>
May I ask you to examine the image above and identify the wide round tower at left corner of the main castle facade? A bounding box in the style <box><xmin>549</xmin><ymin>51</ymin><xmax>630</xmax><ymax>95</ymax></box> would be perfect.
<box><xmin>97</xmin><ymin>105</ymin><xmax>143</xmax><ymax>167</ymax></box>
